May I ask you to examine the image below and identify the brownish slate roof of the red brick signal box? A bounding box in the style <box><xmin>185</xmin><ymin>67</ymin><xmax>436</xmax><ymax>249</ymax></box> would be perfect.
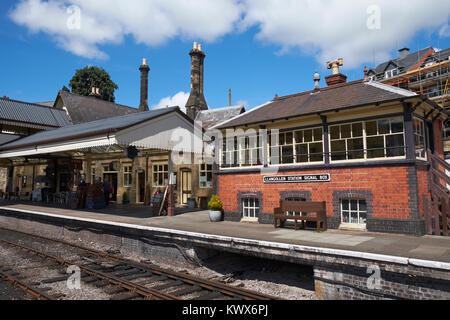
<box><xmin>217</xmin><ymin>80</ymin><xmax>417</xmax><ymax>129</ymax></box>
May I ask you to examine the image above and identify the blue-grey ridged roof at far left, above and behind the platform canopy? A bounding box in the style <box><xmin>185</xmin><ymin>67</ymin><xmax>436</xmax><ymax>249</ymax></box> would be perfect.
<box><xmin>0</xmin><ymin>98</ymin><xmax>70</xmax><ymax>128</ymax></box>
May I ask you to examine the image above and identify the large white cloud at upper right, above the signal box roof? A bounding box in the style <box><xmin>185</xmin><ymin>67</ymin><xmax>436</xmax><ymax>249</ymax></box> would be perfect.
<box><xmin>244</xmin><ymin>0</ymin><xmax>450</xmax><ymax>67</ymax></box>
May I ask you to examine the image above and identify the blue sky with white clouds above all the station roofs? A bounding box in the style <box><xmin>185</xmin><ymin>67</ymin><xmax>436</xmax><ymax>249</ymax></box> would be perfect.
<box><xmin>0</xmin><ymin>0</ymin><xmax>450</xmax><ymax>108</ymax></box>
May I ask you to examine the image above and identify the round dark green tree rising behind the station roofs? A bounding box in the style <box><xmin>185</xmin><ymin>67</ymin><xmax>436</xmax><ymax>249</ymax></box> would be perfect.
<box><xmin>69</xmin><ymin>66</ymin><xmax>119</xmax><ymax>102</ymax></box>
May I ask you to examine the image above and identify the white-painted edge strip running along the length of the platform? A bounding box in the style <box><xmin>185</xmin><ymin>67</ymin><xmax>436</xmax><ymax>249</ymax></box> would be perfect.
<box><xmin>0</xmin><ymin>207</ymin><xmax>450</xmax><ymax>271</ymax></box>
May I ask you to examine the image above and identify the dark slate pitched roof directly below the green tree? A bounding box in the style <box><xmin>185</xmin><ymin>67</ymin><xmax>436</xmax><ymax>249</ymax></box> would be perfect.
<box><xmin>56</xmin><ymin>90</ymin><xmax>138</xmax><ymax>124</ymax></box>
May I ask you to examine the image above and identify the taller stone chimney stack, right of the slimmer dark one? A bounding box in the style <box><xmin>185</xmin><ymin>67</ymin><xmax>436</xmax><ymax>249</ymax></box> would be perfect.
<box><xmin>186</xmin><ymin>42</ymin><xmax>208</xmax><ymax>120</ymax></box>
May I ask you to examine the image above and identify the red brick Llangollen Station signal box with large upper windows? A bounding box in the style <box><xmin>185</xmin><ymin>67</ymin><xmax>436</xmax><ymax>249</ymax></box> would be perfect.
<box><xmin>215</xmin><ymin>60</ymin><xmax>448</xmax><ymax>235</ymax></box>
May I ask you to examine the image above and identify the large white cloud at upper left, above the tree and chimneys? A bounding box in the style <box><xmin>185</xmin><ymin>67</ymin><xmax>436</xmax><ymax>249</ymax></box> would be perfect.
<box><xmin>9</xmin><ymin>0</ymin><xmax>241</xmax><ymax>58</ymax></box>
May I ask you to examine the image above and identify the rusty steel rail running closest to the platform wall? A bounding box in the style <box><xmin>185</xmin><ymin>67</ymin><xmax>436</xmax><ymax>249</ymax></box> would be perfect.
<box><xmin>0</xmin><ymin>227</ymin><xmax>283</xmax><ymax>300</ymax></box>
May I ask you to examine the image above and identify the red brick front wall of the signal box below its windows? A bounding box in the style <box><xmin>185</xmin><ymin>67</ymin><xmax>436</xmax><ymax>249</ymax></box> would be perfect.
<box><xmin>218</xmin><ymin>166</ymin><xmax>410</xmax><ymax>219</ymax></box>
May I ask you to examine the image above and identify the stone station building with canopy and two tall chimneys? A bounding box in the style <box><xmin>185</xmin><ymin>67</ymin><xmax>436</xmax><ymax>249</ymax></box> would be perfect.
<box><xmin>0</xmin><ymin>43</ymin><xmax>245</xmax><ymax>209</ymax></box>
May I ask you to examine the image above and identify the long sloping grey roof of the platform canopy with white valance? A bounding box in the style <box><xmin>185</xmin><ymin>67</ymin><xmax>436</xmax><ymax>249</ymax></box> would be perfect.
<box><xmin>0</xmin><ymin>107</ymin><xmax>181</xmax><ymax>150</ymax></box>
